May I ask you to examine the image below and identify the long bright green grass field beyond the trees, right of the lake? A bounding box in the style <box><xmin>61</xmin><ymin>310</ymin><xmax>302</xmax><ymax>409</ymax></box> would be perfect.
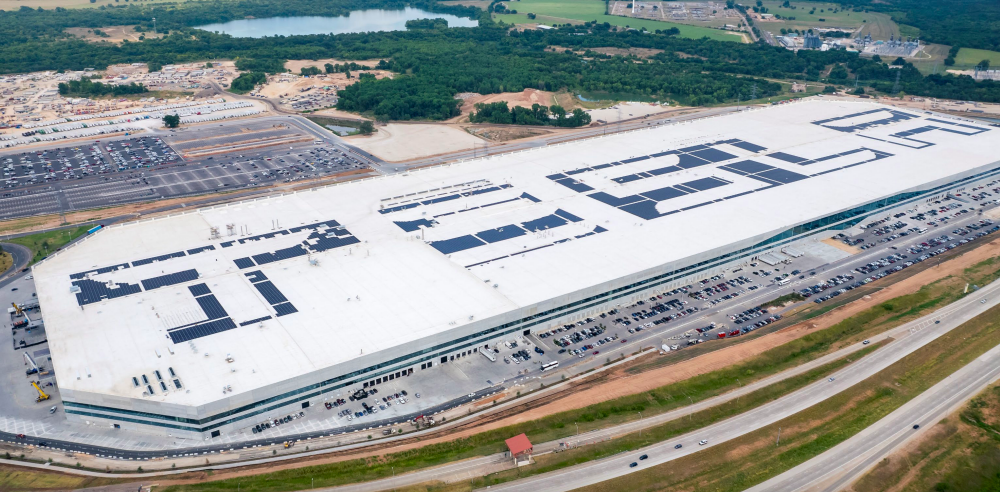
<box><xmin>493</xmin><ymin>0</ymin><xmax>743</xmax><ymax>42</ymax></box>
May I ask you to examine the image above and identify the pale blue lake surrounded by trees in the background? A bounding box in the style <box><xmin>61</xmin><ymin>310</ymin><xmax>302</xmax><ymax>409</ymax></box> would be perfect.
<box><xmin>198</xmin><ymin>7</ymin><xmax>479</xmax><ymax>38</ymax></box>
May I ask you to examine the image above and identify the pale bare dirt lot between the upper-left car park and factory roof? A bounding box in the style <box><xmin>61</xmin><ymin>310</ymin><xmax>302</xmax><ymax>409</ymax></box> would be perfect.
<box><xmin>347</xmin><ymin>123</ymin><xmax>484</xmax><ymax>162</ymax></box>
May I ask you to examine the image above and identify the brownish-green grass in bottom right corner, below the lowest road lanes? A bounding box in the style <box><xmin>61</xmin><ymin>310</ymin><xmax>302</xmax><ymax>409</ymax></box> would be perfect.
<box><xmin>852</xmin><ymin>384</ymin><xmax>1000</xmax><ymax>492</ymax></box>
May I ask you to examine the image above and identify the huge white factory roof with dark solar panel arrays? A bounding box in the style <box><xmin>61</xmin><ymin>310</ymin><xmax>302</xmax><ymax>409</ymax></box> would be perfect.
<box><xmin>34</xmin><ymin>101</ymin><xmax>1000</xmax><ymax>405</ymax></box>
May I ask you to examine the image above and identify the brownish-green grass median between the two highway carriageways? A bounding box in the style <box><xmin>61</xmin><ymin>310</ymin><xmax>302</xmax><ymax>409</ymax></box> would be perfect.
<box><xmin>581</xmin><ymin>284</ymin><xmax>1000</xmax><ymax>492</ymax></box>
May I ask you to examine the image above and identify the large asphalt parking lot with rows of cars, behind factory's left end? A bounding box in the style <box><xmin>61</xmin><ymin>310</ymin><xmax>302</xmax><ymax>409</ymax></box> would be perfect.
<box><xmin>0</xmin><ymin>118</ymin><xmax>376</xmax><ymax>220</ymax></box>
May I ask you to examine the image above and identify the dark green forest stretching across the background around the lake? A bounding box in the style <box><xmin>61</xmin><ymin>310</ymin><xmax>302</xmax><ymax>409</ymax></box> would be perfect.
<box><xmin>0</xmin><ymin>0</ymin><xmax>1000</xmax><ymax>120</ymax></box>
